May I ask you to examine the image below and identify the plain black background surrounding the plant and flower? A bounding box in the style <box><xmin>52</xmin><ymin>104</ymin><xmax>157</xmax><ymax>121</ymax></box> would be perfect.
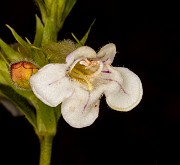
<box><xmin>0</xmin><ymin>0</ymin><xmax>180</xmax><ymax>165</ymax></box>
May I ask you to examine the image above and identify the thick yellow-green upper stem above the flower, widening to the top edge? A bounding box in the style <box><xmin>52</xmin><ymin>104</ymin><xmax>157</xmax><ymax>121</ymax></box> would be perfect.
<box><xmin>38</xmin><ymin>0</ymin><xmax>77</xmax><ymax>45</ymax></box>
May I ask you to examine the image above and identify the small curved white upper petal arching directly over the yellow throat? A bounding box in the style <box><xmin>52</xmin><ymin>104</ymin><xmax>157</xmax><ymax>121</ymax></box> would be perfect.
<box><xmin>66</xmin><ymin>46</ymin><xmax>96</xmax><ymax>66</ymax></box>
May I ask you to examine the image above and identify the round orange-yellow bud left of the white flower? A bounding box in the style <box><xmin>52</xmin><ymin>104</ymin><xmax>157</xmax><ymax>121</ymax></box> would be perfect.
<box><xmin>10</xmin><ymin>61</ymin><xmax>38</xmax><ymax>89</ymax></box>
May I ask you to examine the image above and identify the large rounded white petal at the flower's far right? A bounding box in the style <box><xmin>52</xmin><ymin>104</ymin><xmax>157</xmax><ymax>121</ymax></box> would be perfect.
<box><xmin>105</xmin><ymin>67</ymin><xmax>143</xmax><ymax>111</ymax></box>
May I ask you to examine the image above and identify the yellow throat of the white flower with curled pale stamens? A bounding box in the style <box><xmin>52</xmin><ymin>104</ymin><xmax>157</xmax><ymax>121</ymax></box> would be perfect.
<box><xmin>68</xmin><ymin>59</ymin><xmax>103</xmax><ymax>91</ymax></box>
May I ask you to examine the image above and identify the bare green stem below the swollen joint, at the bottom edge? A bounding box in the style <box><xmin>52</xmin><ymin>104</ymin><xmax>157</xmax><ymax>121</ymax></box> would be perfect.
<box><xmin>39</xmin><ymin>136</ymin><xmax>53</xmax><ymax>165</ymax></box>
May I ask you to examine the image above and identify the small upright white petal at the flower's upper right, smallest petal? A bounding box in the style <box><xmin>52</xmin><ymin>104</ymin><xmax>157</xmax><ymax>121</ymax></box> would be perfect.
<box><xmin>97</xmin><ymin>43</ymin><xmax>116</xmax><ymax>65</ymax></box>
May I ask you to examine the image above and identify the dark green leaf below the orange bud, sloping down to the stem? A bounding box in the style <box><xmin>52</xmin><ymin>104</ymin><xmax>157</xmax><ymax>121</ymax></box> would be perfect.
<box><xmin>0</xmin><ymin>84</ymin><xmax>37</xmax><ymax>128</ymax></box>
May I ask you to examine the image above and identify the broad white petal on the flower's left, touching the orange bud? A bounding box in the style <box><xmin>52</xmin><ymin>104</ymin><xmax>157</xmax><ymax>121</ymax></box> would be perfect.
<box><xmin>30</xmin><ymin>64</ymin><xmax>73</xmax><ymax>107</ymax></box>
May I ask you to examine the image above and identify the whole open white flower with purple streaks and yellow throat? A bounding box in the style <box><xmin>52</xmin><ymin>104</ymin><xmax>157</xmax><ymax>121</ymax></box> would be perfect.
<box><xmin>30</xmin><ymin>43</ymin><xmax>143</xmax><ymax>128</ymax></box>
